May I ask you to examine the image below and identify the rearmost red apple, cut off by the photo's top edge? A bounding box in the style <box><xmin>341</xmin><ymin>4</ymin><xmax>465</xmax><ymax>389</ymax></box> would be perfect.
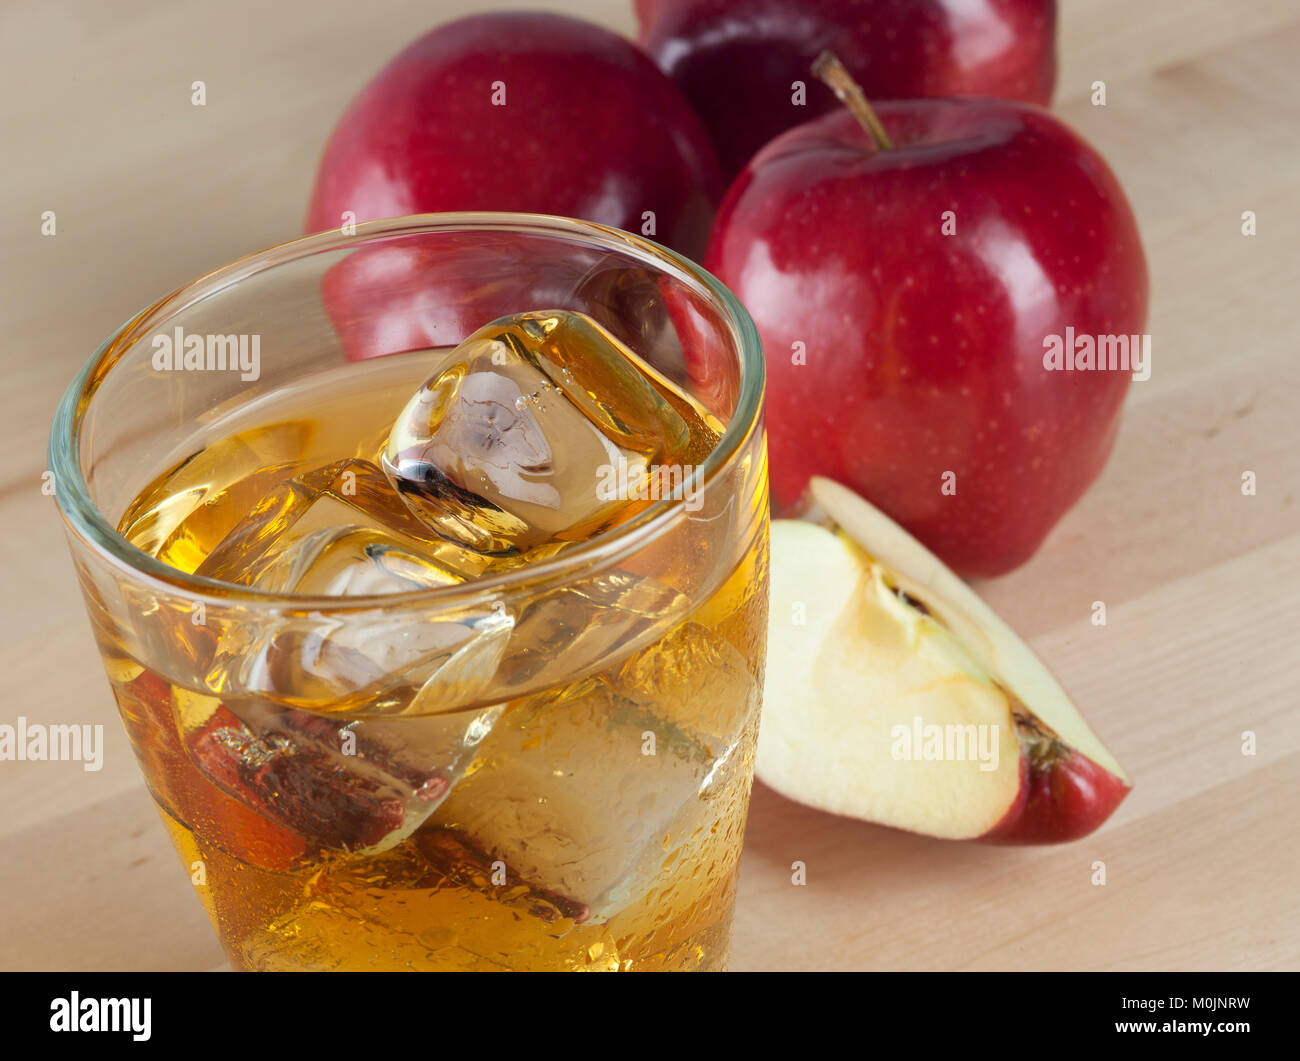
<box><xmin>637</xmin><ymin>0</ymin><xmax>1056</xmax><ymax>177</ymax></box>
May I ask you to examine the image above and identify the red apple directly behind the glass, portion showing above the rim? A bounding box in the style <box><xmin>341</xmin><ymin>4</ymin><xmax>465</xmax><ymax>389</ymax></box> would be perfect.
<box><xmin>306</xmin><ymin>12</ymin><xmax>720</xmax><ymax>255</ymax></box>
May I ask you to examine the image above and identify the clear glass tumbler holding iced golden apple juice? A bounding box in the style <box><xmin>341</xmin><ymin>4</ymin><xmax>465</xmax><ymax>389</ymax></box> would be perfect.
<box><xmin>51</xmin><ymin>213</ymin><xmax>768</xmax><ymax>970</ymax></box>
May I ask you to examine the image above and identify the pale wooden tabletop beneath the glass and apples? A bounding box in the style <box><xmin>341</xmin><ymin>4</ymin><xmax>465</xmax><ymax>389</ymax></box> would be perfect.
<box><xmin>0</xmin><ymin>0</ymin><xmax>1300</xmax><ymax>969</ymax></box>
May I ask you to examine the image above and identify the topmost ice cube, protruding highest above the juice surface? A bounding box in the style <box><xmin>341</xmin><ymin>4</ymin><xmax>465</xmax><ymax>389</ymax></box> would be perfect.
<box><xmin>382</xmin><ymin>309</ymin><xmax>718</xmax><ymax>554</ymax></box>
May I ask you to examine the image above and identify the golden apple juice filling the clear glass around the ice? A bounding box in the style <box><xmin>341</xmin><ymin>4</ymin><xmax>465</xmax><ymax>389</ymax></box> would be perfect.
<box><xmin>104</xmin><ymin>327</ymin><xmax>767</xmax><ymax>970</ymax></box>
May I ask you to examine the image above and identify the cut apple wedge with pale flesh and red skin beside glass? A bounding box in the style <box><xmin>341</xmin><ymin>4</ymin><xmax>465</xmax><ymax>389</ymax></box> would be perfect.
<box><xmin>755</xmin><ymin>478</ymin><xmax>1131</xmax><ymax>844</ymax></box>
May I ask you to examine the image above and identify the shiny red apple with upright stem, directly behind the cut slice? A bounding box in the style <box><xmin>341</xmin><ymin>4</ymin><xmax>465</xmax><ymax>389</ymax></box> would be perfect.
<box><xmin>693</xmin><ymin>62</ymin><xmax>1147</xmax><ymax>576</ymax></box>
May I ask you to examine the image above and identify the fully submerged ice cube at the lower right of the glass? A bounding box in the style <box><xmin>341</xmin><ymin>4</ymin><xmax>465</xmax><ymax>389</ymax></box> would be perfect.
<box><xmin>430</xmin><ymin>622</ymin><xmax>759</xmax><ymax>922</ymax></box>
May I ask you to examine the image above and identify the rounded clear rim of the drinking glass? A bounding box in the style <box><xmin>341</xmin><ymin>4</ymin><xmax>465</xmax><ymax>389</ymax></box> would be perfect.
<box><xmin>48</xmin><ymin>212</ymin><xmax>764</xmax><ymax>614</ymax></box>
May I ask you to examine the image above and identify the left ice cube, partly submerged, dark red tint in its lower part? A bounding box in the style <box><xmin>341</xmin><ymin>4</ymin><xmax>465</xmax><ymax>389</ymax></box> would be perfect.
<box><xmin>178</xmin><ymin>460</ymin><xmax>512</xmax><ymax>850</ymax></box>
